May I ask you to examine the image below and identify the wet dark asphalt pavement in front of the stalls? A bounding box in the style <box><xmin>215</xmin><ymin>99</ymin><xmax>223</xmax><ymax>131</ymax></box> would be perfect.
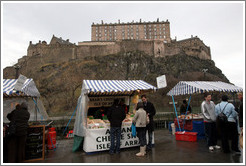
<box><xmin>33</xmin><ymin>129</ymin><xmax>243</xmax><ymax>164</ymax></box>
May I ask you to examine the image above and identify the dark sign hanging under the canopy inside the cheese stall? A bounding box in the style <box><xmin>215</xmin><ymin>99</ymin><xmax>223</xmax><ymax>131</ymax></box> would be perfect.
<box><xmin>89</xmin><ymin>96</ymin><xmax>129</xmax><ymax>107</ymax></box>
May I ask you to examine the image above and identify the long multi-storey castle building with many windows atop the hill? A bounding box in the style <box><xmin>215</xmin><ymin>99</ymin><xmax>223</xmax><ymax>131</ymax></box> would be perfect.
<box><xmin>91</xmin><ymin>19</ymin><xmax>171</xmax><ymax>43</ymax></box>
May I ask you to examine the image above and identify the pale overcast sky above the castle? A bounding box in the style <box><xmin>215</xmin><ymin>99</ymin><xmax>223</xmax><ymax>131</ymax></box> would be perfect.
<box><xmin>1</xmin><ymin>1</ymin><xmax>245</xmax><ymax>87</ymax></box>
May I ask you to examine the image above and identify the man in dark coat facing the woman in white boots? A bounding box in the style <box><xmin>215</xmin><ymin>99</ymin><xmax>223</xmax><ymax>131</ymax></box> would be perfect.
<box><xmin>141</xmin><ymin>95</ymin><xmax>156</xmax><ymax>150</ymax></box>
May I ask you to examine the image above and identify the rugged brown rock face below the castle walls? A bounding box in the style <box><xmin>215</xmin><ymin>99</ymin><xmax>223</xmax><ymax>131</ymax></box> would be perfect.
<box><xmin>3</xmin><ymin>51</ymin><xmax>229</xmax><ymax>114</ymax></box>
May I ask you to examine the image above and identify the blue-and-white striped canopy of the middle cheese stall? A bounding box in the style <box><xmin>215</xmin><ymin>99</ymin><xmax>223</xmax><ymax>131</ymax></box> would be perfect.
<box><xmin>83</xmin><ymin>80</ymin><xmax>157</xmax><ymax>95</ymax></box>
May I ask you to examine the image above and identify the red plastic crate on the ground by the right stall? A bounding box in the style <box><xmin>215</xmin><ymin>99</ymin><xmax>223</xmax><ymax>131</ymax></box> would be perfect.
<box><xmin>175</xmin><ymin>131</ymin><xmax>197</xmax><ymax>142</ymax></box>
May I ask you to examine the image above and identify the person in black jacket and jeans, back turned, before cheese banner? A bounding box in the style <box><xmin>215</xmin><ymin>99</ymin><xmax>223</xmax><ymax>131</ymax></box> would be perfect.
<box><xmin>107</xmin><ymin>99</ymin><xmax>126</xmax><ymax>154</ymax></box>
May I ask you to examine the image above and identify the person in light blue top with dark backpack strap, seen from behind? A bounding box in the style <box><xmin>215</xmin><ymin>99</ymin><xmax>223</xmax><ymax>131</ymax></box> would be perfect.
<box><xmin>215</xmin><ymin>95</ymin><xmax>240</xmax><ymax>153</ymax></box>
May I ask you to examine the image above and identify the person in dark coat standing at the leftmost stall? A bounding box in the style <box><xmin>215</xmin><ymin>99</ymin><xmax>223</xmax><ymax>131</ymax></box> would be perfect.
<box><xmin>7</xmin><ymin>102</ymin><xmax>30</xmax><ymax>163</ymax></box>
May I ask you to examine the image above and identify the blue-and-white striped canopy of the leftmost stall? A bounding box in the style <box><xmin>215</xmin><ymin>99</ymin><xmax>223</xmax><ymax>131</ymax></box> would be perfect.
<box><xmin>3</xmin><ymin>78</ymin><xmax>40</xmax><ymax>97</ymax></box>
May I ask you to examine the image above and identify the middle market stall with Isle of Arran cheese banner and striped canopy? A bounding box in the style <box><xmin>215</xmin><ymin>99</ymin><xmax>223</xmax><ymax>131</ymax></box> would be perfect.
<box><xmin>73</xmin><ymin>80</ymin><xmax>156</xmax><ymax>152</ymax></box>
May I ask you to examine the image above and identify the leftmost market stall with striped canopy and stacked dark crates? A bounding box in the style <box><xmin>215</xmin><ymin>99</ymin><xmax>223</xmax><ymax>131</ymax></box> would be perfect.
<box><xmin>2</xmin><ymin>75</ymin><xmax>49</xmax><ymax>162</ymax></box>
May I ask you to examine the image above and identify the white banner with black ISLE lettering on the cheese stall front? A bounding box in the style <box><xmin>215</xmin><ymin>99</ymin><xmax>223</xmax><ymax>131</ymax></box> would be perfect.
<box><xmin>83</xmin><ymin>126</ymin><xmax>154</xmax><ymax>152</ymax></box>
